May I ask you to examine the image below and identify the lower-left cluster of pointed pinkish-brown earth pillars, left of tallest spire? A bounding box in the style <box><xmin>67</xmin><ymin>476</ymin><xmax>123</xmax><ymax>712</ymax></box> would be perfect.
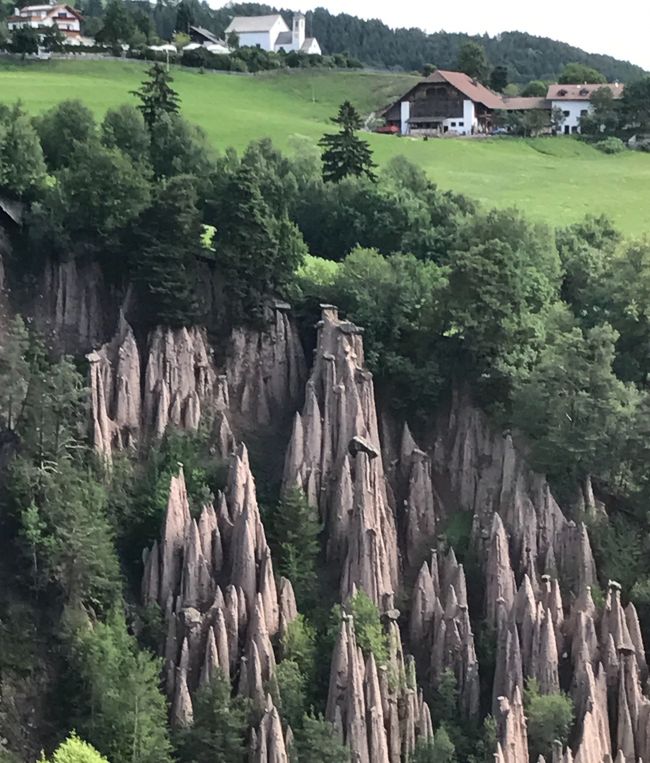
<box><xmin>142</xmin><ymin>445</ymin><xmax>297</xmax><ymax>724</ymax></box>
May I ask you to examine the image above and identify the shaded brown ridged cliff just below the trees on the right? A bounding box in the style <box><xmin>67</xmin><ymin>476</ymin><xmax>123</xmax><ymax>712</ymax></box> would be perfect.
<box><xmin>432</xmin><ymin>392</ymin><xmax>596</xmax><ymax>593</ymax></box>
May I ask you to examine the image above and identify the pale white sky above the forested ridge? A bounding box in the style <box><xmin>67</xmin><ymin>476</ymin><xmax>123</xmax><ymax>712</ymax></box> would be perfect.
<box><xmin>240</xmin><ymin>0</ymin><xmax>650</xmax><ymax>71</ymax></box>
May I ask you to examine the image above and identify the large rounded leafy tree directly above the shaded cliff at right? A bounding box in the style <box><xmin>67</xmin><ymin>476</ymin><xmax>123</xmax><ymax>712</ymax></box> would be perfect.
<box><xmin>448</xmin><ymin>211</ymin><xmax>560</xmax><ymax>397</ymax></box>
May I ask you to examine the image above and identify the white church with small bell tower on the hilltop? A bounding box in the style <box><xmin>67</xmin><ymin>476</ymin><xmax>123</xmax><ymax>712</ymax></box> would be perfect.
<box><xmin>226</xmin><ymin>13</ymin><xmax>321</xmax><ymax>55</ymax></box>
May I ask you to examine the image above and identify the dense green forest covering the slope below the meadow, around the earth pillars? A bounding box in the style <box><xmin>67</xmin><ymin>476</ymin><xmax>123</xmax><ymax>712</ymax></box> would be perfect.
<box><xmin>0</xmin><ymin>62</ymin><xmax>650</xmax><ymax>763</ymax></box>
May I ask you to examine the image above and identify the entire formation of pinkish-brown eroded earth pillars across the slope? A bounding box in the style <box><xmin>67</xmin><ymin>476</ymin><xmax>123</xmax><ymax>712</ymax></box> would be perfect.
<box><xmin>125</xmin><ymin>306</ymin><xmax>650</xmax><ymax>763</ymax></box>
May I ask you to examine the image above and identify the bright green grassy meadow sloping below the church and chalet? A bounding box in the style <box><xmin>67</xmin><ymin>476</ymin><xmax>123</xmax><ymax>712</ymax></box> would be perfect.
<box><xmin>0</xmin><ymin>61</ymin><xmax>650</xmax><ymax>234</ymax></box>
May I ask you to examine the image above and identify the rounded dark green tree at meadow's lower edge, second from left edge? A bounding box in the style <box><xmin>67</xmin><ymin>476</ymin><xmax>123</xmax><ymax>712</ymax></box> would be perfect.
<box><xmin>34</xmin><ymin>100</ymin><xmax>95</xmax><ymax>171</ymax></box>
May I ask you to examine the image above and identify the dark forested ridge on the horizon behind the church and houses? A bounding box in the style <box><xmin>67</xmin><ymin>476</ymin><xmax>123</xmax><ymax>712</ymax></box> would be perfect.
<box><xmin>0</xmin><ymin>0</ymin><xmax>644</xmax><ymax>85</ymax></box>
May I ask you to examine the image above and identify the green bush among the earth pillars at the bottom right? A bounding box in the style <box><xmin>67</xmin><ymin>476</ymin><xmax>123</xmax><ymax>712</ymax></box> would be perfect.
<box><xmin>524</xmin><ymin>679</ymin><xmax>573</xmax><ymax>760</ymax></box>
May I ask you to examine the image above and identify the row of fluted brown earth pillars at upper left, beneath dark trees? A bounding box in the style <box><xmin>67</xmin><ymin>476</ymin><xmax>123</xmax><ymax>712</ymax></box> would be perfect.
<box><xmin>87</xmin><ymin>305</ymin><xmax>305</xmax><ymax>461</ymax></box>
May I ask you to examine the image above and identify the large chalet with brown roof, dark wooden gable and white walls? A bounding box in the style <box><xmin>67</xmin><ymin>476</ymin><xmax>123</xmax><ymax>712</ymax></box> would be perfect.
<box><xmin>382</xmin><ymin>69</ymin><xmax>550</xmax><ymax>135</ymax></box>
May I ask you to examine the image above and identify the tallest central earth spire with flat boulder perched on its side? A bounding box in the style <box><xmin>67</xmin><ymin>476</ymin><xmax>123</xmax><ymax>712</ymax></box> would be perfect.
<box><xmin>284</xmin><ymin>306</ymin><xmax>398</xmax><ymax>603</ymax></box>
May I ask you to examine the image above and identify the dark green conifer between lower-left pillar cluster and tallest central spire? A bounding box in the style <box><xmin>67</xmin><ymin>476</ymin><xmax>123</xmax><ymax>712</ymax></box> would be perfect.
<box><xmin>272</xmin><ymin>488</ymin><xmax>321</xmax><ymax>610</ymax></box>
